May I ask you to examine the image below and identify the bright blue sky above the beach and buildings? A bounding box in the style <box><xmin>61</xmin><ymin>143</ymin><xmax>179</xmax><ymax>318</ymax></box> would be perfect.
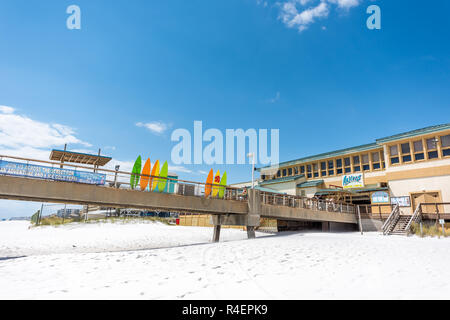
<box><xmin>0</xmin><ymin>0</ymin><xmax>450</xmax><ymax>218</ymax></box>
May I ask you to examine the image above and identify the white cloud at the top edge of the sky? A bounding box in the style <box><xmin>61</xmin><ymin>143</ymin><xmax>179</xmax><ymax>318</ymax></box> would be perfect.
<box><xmin>278</xmin><ymin>0</ymin><xmax>360</xmax><ymax>32</ymax></box>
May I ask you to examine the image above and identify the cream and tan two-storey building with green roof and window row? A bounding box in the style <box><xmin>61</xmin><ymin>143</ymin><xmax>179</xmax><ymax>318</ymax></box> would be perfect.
<box><xmin>257</xmin><ymin>123</ymin><xmax>450</xmax><ymax>215</ymax></box>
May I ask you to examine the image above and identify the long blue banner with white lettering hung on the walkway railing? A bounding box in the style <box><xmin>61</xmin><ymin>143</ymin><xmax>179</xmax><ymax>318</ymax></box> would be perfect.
<box><xmin>0</xmin><ymin>160</ymin><xmax>106</xmax><ymax>185</ymax></box>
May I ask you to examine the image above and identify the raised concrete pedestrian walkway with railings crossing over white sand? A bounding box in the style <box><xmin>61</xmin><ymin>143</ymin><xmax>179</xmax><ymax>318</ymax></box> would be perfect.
<box><xmin>0</xmin><ymin>156</ymin><xmax>358</xmax><ymax>240</ymax></box>
